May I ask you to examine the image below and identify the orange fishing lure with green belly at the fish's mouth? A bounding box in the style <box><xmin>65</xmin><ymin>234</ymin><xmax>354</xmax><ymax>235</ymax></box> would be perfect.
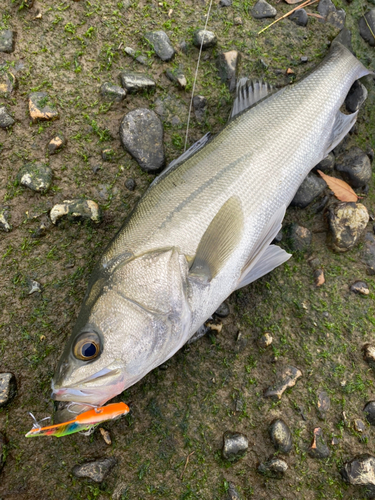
<box><xmin>26</xmin><ymin>403</ymin><xmax>129</xmax><ymax>437</ymax></box>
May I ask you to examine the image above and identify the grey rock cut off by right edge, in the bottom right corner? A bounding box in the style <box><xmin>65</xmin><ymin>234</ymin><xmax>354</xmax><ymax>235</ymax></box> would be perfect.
<box><xmin>340</xmin><ymin>453</ymin><xmax>375</xmax><ymax>498</ymax></box>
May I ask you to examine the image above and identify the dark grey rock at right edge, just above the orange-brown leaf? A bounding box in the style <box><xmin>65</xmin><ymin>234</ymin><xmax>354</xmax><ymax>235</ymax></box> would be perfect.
<box><xmin>335</xmin><ymin>147</ymin><xmax>372</xmax><ymax>188</ymax></box>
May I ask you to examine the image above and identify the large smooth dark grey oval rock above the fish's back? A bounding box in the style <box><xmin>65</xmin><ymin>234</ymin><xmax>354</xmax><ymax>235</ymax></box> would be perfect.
<box><xmin>120</xmin><ymin>108</ymin><xmax>165</xmax><ymax>174</ymax></box>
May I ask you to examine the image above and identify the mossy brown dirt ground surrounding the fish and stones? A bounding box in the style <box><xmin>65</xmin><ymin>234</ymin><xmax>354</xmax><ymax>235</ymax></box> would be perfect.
<box><xmin>0</xmin><ymin>0</ymin><xmax>375</xmax><ymax>500</ymax></box>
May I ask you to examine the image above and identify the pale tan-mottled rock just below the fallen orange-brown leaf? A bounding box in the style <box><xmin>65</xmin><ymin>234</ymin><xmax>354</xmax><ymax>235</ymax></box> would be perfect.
<box><xmin>328</xmin><ymin>202</ymin><xmax>369</xmax><ymax>252</ymax></box>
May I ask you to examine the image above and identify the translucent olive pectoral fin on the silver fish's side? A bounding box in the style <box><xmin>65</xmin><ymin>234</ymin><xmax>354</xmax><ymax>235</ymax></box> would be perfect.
<box><xmin>189</xmin><ymin>197</ymin><xmax>243</xmax><ymax>282</ymax></box>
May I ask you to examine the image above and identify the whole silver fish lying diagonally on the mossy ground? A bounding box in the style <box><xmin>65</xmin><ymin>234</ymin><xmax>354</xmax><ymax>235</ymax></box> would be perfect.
<box><xmin>52</xmin><ymin>43</ymin><xmax>371</xmax><ymax>408</ymax></box>
